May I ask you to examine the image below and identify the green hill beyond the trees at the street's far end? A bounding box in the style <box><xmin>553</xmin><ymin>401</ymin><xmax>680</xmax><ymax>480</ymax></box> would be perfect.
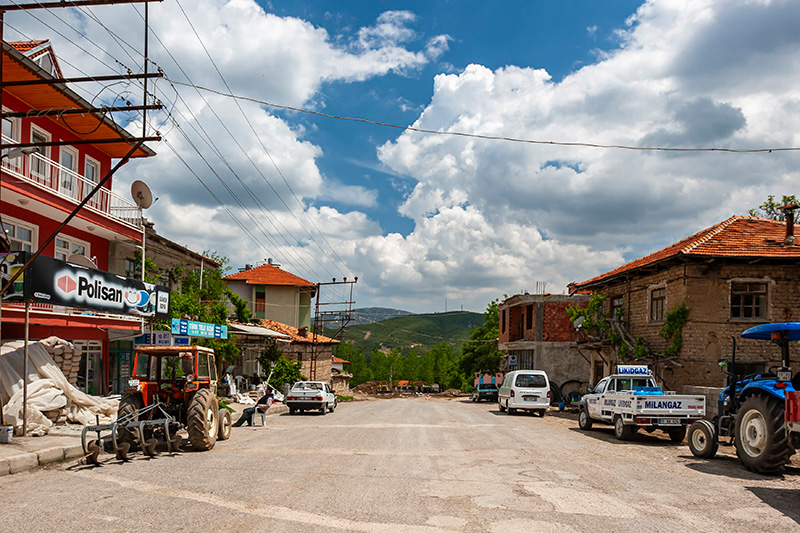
<box><xmin>330</xmin><ymin>309</ymin><xmax>483</xmax><ymax>354</ymax></box>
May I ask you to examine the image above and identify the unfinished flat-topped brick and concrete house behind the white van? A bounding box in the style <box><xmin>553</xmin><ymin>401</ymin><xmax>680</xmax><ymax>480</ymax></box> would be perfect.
<box><xmin>498</xmin><ymin>293</ymin><xmax>589</xmax><ymax>385</ymax></box>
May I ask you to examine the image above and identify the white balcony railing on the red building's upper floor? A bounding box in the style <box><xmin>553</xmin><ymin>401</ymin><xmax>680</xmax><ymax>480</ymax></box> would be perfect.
<box><xmin>2</xmin><ymin>135</ymin><xmax>142</xmax><ymax>228</ymax></box>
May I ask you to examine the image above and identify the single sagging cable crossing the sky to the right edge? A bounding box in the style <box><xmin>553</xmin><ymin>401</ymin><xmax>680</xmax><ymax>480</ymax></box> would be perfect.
<box><xmin>167</xmin><ymin>78</ymin><xmax>800</xmax><ymax>154</ymax></box>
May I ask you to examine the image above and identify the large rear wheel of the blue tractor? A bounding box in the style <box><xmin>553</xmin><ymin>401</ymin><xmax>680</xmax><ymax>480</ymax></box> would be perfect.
<box><xmin>734</xmin><ymin>394</ymin><xmax>794</xmax><ymax>474</ymax></box>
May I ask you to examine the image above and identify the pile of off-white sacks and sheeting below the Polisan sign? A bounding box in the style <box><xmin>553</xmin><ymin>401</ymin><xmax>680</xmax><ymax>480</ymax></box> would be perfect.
<box><xmin>0</xmin><ymin>337</ymin><xmax>119</xmax><ymax>435</ymax></box>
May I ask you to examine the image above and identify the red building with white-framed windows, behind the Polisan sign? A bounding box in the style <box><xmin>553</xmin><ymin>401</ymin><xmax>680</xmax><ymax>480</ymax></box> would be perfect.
<box><xmin>0</xmin><ymin>41</ymin><xmax>155</xmax><ymax>394</ymax></box>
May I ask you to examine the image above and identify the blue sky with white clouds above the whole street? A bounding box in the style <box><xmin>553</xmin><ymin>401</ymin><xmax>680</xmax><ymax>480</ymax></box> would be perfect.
<box><xmin>6</xmin><ymin>0</ymin><xmax>800</xmax><ymax>313</ymax></box>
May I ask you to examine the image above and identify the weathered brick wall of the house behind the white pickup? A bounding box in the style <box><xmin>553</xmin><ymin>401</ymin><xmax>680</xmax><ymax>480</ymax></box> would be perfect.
<box><xmin>588</xmin><ymin>262</ymin><xmax>800</xmax><ymax>391</ymax></box>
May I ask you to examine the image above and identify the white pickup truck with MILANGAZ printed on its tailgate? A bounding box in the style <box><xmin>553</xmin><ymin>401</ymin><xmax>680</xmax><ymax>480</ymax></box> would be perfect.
<box><xmin>578</xmin><ymin>365</ymin><xmax>706</xmax><ymax>442</ymax></box>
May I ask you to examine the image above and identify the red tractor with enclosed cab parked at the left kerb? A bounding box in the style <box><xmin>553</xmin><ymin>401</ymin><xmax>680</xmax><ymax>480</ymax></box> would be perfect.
<box><xmin>117</xmin><ymin>346</ymin><xmax>231</xmax><ymax>450</ymax></box>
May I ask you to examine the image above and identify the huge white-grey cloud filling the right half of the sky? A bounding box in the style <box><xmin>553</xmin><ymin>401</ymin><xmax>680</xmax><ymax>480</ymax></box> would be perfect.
<box><xmin>378</xmin><ymin>0</ymin><xmax>800</xmax><ymax>300</ymax></box>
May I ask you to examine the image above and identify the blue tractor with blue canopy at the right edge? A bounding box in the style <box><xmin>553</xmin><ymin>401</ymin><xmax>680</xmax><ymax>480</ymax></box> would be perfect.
<box><xmin>688</xmin><ymin>322</ymin><xmax>800</xmax><ymax>474</ymax></box>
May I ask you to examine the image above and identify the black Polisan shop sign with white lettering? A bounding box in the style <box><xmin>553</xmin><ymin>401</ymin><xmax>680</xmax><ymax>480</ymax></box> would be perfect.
<box><xmin>3</xmin><ymin>254</ymin><xmax>169</xmax><ymax>318</ymax></box>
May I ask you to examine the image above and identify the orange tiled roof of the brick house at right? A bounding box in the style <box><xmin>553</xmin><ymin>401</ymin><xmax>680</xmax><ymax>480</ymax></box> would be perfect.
<box><xmin>573</xmin><ymin>216</ymin><xmax>800</xmax><ymax>289</ymax></box>
